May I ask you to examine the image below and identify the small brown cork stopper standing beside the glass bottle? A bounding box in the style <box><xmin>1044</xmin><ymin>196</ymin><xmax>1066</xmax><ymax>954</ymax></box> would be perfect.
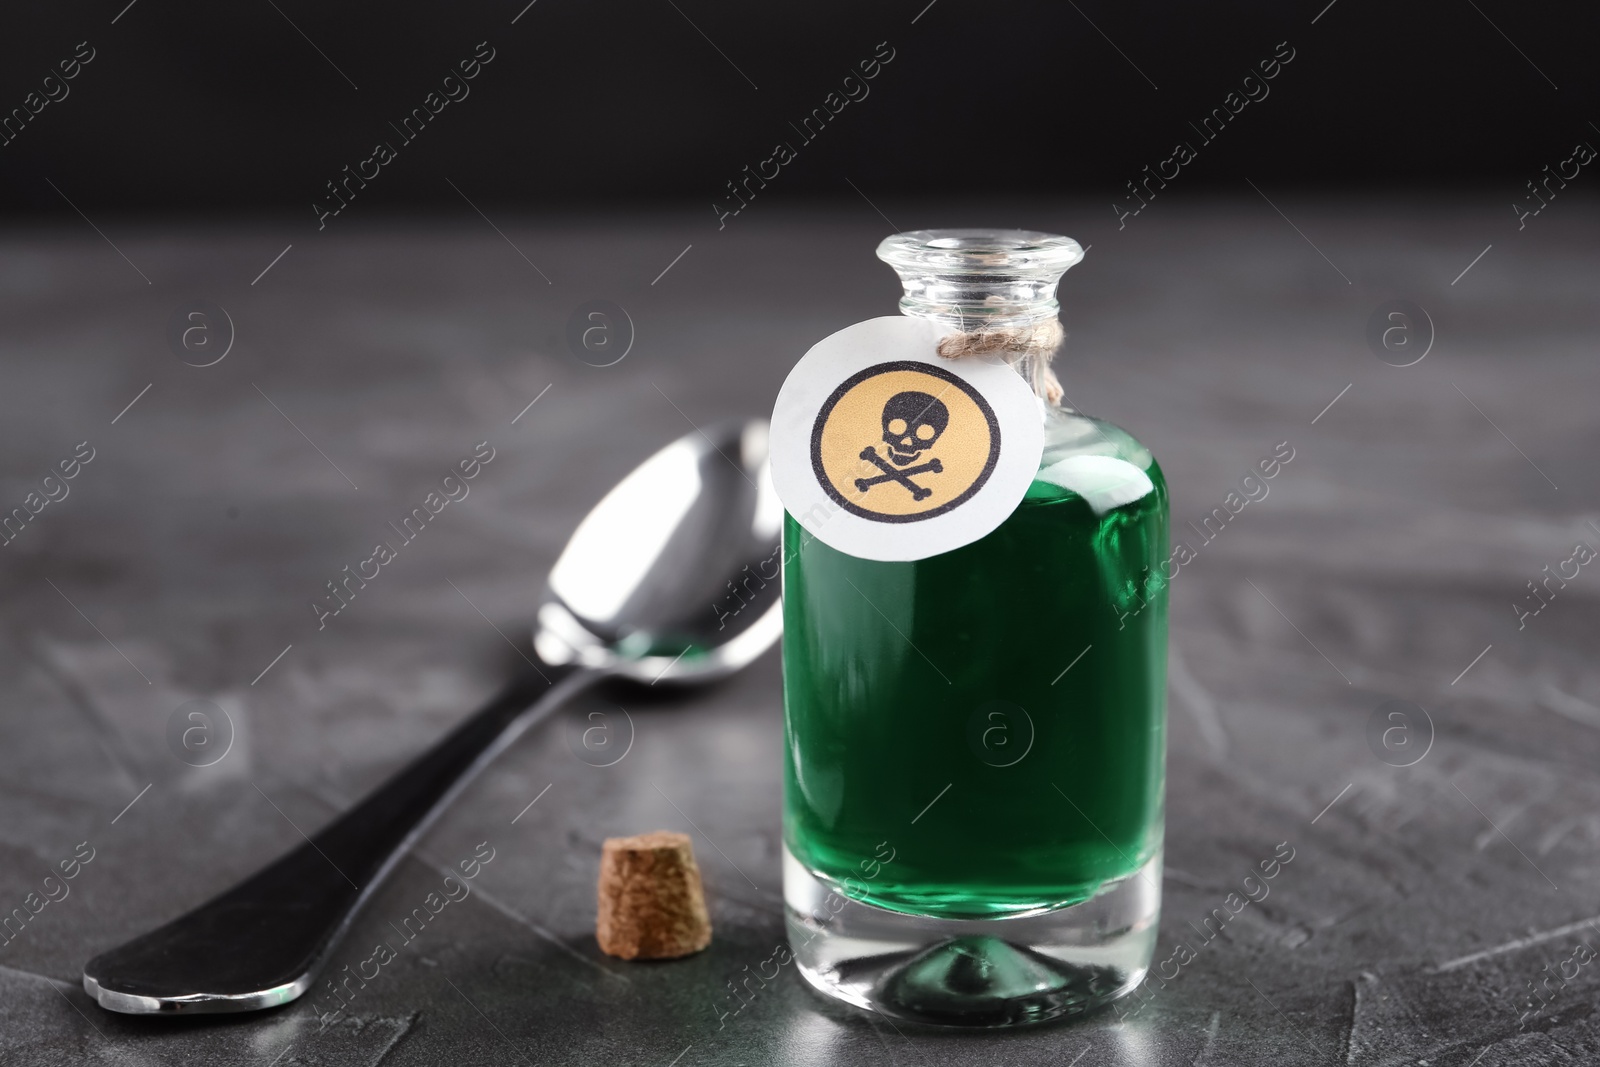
<box><xmin>595</xmin><ymin>830</ymin><xmax>710</xmax><ymax>960</ymax></box>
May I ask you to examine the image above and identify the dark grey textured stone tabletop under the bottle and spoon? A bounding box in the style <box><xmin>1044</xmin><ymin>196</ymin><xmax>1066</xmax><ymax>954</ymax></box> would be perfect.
<box><xmin>0</xmin><ymin>198</ymin><xmax>1600</xmax><ymax>1067</ymax></box>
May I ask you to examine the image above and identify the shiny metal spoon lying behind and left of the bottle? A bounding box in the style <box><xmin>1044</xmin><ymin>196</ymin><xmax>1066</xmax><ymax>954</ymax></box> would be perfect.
<box><xmin>83</xmin><ymin>422</ymin><xmax>782</xmax><ymax>1014</ymax></box>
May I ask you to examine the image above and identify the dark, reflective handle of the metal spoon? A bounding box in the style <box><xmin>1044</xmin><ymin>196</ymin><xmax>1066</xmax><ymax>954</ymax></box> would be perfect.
<box><xmin>83</xmin><ymin>662</ymin><xmax>600</xmax><ymax>1014</ymax></box>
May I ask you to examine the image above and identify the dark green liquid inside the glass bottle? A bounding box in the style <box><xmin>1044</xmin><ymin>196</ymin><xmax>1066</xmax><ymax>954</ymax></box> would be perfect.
<box><xmin>784</xmin><ymin>413</ymin><xmax>1168</xmax><ymax>917</ymax></box>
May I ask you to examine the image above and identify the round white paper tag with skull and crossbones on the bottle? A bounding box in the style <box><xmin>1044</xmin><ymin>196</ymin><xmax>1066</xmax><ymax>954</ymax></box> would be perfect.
<box><xmin>771</xmin><ymin>315</ymin><xmax>1045</xmax><ymax>560</ymax></box>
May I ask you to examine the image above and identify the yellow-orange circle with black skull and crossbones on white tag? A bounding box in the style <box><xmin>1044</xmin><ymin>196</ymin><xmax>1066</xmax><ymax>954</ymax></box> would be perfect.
<box><xmin>811</xmin><ymin>360</ymin><xmax>1000</xmax><ymax>523</ymax></box>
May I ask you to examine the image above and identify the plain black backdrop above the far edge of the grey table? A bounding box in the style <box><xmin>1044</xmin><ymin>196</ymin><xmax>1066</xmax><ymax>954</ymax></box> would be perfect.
<box><xmin>0</xmin><ymin>0</ymin><xmax>1600</xmax><ymax>221</ymax></box>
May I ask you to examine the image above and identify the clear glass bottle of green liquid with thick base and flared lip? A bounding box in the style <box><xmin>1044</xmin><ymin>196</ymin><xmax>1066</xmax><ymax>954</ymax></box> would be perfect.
<box><xmin>782</xmin><ymin>230</ymin><xmax>1168</xmax><ymax>1025</ymax></box>
